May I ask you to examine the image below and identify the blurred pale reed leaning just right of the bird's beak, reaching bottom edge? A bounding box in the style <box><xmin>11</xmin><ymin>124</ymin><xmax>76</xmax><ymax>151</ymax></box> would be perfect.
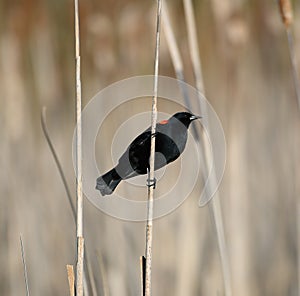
<box><xmin>183</xmin><ymin>0</ymin><xmax>232</xmax><ymax>296</ymax></box>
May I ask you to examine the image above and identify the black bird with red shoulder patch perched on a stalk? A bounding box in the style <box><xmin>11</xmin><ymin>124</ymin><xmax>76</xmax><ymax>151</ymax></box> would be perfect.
<box><xmin>96</xmin><ymin>112</ymin><xmax>201</xmax><ymax>196</ymax></box>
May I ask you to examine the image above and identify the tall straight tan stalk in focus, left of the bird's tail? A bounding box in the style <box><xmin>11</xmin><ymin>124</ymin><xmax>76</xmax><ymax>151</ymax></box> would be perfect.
<box><xmin>74</xmin><ymin>0</ymin><xmax>84</xmax><ymax>296</ymax></box>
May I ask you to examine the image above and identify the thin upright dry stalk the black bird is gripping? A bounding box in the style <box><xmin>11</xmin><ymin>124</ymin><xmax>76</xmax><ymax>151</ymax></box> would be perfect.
<box><xmin>145</xmin><ymin>0</ymin><xmax>162</xmax><ymax>296</ymax></box>
